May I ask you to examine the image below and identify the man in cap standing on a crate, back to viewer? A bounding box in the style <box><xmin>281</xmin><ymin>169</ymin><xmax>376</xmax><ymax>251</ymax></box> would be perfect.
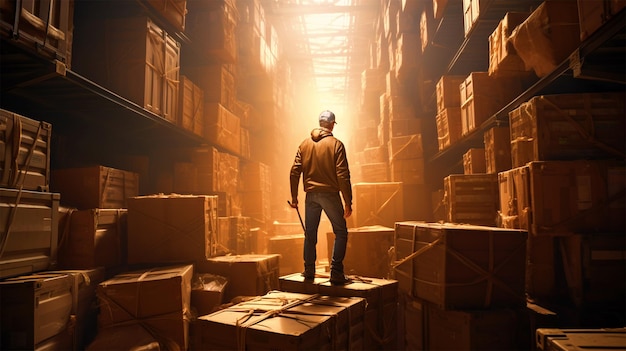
<box><xmin>289</xmin><ymin>110</ymin><xmax>352</xmax><ymax>285</ymax></box>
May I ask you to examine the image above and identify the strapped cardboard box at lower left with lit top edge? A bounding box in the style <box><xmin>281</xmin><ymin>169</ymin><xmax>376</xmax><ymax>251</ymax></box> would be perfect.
<box><xmin>97</xmin><ymin>265</ymin><xmax>193</xmax><ymax>350</ymax></box>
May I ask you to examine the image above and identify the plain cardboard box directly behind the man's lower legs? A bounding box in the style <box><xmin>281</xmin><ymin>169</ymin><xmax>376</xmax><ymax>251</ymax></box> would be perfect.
<box><xmin>326</xmin><ymin>225</ymin><xmax>394</xmax><ymax>279</ymax></box>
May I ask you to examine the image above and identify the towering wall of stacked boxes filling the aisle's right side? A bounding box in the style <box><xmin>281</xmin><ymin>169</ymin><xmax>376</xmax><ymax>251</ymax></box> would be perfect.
<box><xmin>351</xmin><ymin>0</ymin><xmax>626</xmax><ymax>350</ymax></box>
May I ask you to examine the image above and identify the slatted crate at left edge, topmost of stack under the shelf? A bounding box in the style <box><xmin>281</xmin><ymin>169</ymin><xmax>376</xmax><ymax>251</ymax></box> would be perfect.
<box><xmin>0</xmin><ymin>109</ymin><xmax>52</xmax><ymax>191</ymax></box>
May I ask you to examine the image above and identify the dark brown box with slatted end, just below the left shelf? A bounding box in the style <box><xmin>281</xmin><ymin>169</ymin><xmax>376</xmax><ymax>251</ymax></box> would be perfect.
<box><xmin>50</xmin><ymin>166</ymin><xmax>139</xmax><ymax>210</ymax></box>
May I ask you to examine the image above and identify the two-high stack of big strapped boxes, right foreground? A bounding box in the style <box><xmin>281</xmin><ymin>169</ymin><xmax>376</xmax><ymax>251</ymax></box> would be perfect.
<box><xmin>394</xmin><ymin>221</ymin><xmax>527</xmax><ymax>350</ymax></box>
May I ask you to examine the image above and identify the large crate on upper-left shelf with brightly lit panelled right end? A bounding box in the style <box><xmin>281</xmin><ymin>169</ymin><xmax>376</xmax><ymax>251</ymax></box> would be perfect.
<box><xmin>75</xmin><ymin>16</ymin><xmax>180</xmax><ymax>124</ymax></box>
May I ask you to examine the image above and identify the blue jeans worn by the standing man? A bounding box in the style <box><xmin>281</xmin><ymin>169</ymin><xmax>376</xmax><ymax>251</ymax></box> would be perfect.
<box><xmin>304</xmin><ymin>192</ymin><xmax>348</xmax><ymax>275</ymax></box>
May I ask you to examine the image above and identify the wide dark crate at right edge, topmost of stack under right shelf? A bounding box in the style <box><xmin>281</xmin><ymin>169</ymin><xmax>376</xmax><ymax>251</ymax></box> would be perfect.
<box><xmin>509</xmin><ymin>93</ymin><xmax>626</xmax><ymax>167</ymax></box>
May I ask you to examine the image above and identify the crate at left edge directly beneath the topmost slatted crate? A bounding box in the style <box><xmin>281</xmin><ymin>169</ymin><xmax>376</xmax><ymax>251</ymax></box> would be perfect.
<box><xmin>0</xmin><ymin>188</ymin><xmax>60</xmax><ymax>278</ymax></box>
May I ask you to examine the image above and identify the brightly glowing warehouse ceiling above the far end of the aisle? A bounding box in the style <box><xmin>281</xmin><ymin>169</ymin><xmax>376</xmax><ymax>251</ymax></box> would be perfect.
<box><xmin>265</xmin><ymin>0</ymin><xmax>379</xmax><ymax>116</ymax></box>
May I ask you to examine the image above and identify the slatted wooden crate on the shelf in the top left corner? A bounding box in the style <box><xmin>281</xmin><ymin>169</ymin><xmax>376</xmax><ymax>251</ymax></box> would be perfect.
<box><xmin>0</xmin><ymin>0</ymin><xmax>74</xmax><ymax>68</ymax></box>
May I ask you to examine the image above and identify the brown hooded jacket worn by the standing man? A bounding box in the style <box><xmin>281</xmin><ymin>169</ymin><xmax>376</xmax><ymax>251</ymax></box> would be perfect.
<box><xmin>290</xmin><ymin>127</ymin><xmax>352</xmax><ymax>205</ymax></box>
